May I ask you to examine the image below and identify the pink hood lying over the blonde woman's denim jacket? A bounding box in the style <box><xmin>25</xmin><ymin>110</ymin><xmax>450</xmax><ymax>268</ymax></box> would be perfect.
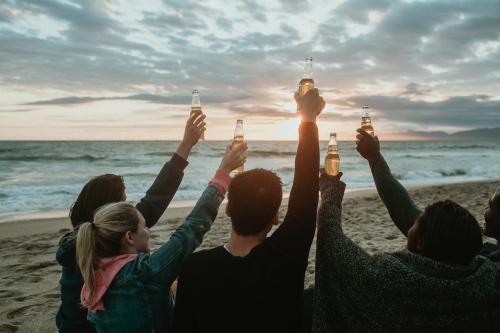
<box><xmin>80</xmin><ymin>254</ymin><xmax>137</xmax><ymax>312</ymax></box>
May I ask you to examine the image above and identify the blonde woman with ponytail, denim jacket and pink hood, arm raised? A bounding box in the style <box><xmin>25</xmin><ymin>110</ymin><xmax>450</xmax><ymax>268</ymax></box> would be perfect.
<box><xmin>76</xmin><ymin>145</ymin><xmax>247</xmax><ymax>333</ymax></box>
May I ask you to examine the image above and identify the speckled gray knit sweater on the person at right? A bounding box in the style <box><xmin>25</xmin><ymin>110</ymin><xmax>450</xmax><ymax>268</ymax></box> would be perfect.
<box><xmin>313</xmin><ymin>177</ymin><xmax>500</xmax><ymax>332</ymax></box>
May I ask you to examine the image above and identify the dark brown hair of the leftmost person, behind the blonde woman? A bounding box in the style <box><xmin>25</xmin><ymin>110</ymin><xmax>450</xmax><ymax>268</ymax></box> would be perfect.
<box><xmin>69</xmin><ymin>173</ymin><xmax>125</xmax><ymax>228</ymax></box>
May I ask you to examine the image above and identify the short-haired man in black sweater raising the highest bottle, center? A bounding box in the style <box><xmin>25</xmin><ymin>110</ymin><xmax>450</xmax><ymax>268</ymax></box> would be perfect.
<box><xmin>174</xmin><ymin>90</ymin><xmax>324</xmax><ymax>332</ymax></box>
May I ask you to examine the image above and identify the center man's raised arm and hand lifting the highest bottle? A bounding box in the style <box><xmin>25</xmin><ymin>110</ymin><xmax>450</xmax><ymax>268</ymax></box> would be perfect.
<box><xmin>268</xmin><ymin>89</ymin><xmax>325</xmax><ymax>267</ymax></box>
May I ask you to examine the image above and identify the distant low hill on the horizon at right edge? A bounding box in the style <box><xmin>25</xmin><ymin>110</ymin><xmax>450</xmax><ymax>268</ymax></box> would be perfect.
<box><xmin>399</xmin><ymin>127</ymin><xmax>500</xmax><ymax>141</ymax></box>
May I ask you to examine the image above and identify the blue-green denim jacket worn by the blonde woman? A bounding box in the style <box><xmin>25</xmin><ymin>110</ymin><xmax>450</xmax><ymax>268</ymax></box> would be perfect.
<box><xmin>88</xmin><ymin>185</ymin><xmax>223</xmax><ymax>333</ymax></box>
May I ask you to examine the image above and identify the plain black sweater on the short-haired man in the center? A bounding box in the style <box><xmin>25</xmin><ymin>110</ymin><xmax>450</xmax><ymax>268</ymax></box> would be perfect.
<box><xmin>174</xmin><ymin>123</ymin><xmax>319</xmax><ymax>333</ymax></box>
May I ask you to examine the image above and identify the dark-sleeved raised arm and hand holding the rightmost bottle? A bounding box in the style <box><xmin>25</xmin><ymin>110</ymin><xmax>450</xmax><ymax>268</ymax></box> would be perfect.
<box><xmin>356</xmin><ymin>129</ymin><xmax>422</xmax><ymax>236</ymax></box>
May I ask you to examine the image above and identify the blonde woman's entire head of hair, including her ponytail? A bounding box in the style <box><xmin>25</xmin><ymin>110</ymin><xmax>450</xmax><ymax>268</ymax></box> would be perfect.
<box><xmin>76</xmin><ymin>202</ymin><xmax>139</xmax><ymax>302</ymax></box>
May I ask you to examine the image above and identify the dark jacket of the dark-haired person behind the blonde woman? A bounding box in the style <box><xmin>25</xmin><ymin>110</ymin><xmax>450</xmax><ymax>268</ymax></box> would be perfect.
<box><xmin>56</xmin><ymin>154</ymin><xmax>188</xmax><ymax>333</ymax></box>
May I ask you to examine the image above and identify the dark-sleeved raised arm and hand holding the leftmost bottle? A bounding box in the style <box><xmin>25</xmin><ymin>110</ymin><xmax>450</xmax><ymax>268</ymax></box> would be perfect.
<box><xmin>136</xmin><ymin>113</ymin><xmax>205</xmax><ymax>228</ymax></box>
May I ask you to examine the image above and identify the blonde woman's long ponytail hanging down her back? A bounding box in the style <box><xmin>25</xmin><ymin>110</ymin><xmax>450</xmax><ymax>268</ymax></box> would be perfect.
<box><xmin>76</xmin><ymin>222</ymin><xmax>97</xmax><ymax>301</ymax></box>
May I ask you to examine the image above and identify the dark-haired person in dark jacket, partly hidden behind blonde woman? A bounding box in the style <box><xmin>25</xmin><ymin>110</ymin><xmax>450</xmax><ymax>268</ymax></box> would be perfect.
<box><xmin>56</xmin><ymin>113</ymin><xmax>205</xmax><ymax>333</ymax></box>
